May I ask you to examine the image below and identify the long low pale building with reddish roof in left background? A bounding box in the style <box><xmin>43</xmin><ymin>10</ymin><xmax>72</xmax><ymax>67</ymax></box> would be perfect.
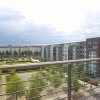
<box><xmin>0</xmin><ymin>45</ymin><xmax>42</xmax><ymax>56</ymax></box>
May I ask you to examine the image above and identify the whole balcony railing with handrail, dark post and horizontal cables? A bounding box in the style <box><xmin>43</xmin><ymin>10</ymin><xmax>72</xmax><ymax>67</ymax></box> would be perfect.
<box><xmin>0</xmin><ymin>58</ymin><xmax>100</xmax><ymax>100</ymax></box>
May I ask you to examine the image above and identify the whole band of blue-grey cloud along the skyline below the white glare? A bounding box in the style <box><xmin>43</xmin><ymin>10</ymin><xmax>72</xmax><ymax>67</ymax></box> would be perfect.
<box><xmin>0</xmin><ymin>8</ymin><xmax>100</xmax><ymax>45</ymax></box>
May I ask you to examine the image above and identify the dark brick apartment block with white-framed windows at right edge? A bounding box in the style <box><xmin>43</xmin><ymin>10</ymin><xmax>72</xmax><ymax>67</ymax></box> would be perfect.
<box><xmin>86</xmin><ymin>37</ymin><xmax>100</xmax><ymax>76</ymax></box>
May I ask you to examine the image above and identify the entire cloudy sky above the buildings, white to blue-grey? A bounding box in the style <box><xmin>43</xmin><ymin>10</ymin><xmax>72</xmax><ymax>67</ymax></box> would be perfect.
<box><xmin>0</xmin><ymin>0</ymin><xmax>100</xmax><ymax>45</ymax></box>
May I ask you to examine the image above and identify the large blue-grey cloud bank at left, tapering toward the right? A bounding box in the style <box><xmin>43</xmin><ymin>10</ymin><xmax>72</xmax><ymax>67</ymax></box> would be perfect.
<box><xmin>0</xmin><ymin>8</ymin><xmax>69</xmax><ymax>45</ymax></box>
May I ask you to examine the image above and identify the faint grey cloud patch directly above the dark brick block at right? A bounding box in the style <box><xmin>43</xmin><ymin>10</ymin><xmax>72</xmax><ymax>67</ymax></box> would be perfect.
<box><xmin>80</xmin><ymin>12</ymin><xmax>100</xmax><ymax>38</ymax></box>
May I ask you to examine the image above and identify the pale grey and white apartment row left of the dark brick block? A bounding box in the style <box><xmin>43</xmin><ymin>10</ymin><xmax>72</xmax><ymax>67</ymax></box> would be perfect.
<box><xmin>42</xmin><ymin>41</ymin><xmax>86</xmax><ymax>61</ymax></box>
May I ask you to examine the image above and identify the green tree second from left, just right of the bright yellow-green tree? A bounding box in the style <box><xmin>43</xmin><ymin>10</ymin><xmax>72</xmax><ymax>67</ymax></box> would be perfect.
<box><xmin>27</xmin><ymin>73</ymin><xmax>46</xmax><ymax>100</ymax></box>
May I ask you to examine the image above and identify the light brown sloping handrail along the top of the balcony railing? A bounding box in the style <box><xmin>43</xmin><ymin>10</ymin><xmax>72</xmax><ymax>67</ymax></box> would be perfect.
<box><xmin>0</xmin><ymin>58</ymin><xmax>100</xmax><ymax>70</ymax></box>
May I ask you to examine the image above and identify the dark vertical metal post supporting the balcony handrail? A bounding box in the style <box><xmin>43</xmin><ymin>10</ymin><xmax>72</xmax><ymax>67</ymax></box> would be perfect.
<box><xmin>68</xmin><ymin>64</ymin><xmax>72</xmax><ymax>100</ymax></box>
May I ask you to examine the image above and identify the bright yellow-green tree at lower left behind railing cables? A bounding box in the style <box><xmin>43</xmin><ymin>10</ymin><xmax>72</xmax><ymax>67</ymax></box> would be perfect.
<box><xmin>6</xmin><ymin>74</ymin><xmax>24</xmax><ymax>100</ymax></box>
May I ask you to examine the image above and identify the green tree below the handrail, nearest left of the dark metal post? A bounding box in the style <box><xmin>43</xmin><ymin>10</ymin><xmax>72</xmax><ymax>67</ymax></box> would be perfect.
<box><xmin>46</xmin><ymin>65</ymin><xmax>64</xmax><ymax>96</ymax></box>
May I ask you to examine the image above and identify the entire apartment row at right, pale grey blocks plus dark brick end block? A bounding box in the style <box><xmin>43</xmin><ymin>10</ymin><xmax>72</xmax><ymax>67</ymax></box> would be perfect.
<box><xmin>42</xmin><ymin>37</ymin><xmax>100</xmax><ymax>76</ymax></box>
